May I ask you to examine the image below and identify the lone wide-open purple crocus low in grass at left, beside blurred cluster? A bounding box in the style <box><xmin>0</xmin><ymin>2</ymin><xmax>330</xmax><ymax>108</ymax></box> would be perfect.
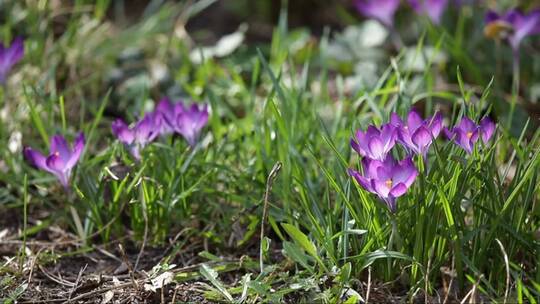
<box><xmin>23</xmin><ymin>133</ymin><xmax>85</xmax><ymax>189</ymax></box>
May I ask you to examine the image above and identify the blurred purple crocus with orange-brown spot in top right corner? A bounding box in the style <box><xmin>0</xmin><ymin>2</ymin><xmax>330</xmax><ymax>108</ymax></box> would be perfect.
<box><xmin>484</xmin><ymin>9</ymin><xmax>540</xmax><ymax>52</ymax></box>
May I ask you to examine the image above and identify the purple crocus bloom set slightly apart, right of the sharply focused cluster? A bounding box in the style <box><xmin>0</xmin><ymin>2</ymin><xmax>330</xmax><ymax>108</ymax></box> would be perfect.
<box><xmin>445</xmin><ymin>117</ymin><xmax>495</xmax><ymax>154</ymax></box>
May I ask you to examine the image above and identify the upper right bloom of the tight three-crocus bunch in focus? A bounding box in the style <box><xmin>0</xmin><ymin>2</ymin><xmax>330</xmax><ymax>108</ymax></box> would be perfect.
<box><xmin>390</xmin><ymin>110</ymin><xmax>442</xmax><ymax>157</ymax></box>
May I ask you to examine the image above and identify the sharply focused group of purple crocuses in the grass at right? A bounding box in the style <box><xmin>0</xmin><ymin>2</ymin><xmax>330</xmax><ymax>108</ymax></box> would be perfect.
<box><xmin>348</xmin><ymin>110</ymin><xmax>495</xmax><ymax>212</ymax></box>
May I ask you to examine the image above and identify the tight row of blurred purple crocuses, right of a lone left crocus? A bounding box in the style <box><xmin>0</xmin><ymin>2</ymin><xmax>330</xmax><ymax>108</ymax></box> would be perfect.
<box><xmin>112</xmin><ymin>98</ymin><xmax>208</xmax><ymax>159</ymax></box>
